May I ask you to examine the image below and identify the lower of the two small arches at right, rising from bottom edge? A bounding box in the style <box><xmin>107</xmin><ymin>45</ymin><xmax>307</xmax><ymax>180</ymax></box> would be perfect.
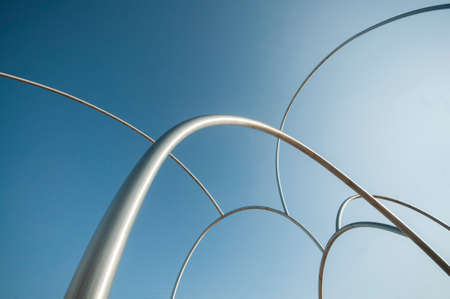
<box><xmin>319</xmin><ymin>222</ymin><xmax>407</xmax><ymax>299</ymax></box>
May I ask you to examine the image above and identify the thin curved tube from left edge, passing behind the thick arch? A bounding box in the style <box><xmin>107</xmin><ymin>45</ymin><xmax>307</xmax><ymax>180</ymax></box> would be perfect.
<box><xmin>0</xmin><ymin>72</ymin><xmax>224</xmax><ymax>216</ymax></box>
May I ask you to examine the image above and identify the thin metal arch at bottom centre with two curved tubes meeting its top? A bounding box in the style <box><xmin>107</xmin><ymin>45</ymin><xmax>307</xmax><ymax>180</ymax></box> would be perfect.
<box><xmin>170</xmin><ymin>206</ymin><xmax>324</xmax><ymax>299</ymax></box>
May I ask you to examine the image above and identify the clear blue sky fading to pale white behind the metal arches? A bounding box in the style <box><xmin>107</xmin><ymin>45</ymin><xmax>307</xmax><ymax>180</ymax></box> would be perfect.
<box><xmin>0</xmin><ymin>0</ymin><xmax>450</xmax><ymax>299</ymax></box>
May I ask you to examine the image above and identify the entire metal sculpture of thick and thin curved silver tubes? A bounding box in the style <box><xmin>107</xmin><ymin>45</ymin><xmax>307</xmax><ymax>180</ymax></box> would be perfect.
<box><xmin>0</xmin><ymin>4</ymin><xmax>450</xmax><ymax>298</ymax></box>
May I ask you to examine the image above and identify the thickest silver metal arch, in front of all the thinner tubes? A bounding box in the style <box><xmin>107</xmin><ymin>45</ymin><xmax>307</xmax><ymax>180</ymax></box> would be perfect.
<box><xmin>66</xmin><ymin>115</ymin><xmax>450</xmax><ymax>298</ymax></box>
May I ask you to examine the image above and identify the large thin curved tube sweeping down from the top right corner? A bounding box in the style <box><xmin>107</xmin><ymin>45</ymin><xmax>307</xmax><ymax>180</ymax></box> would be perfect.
<box><xmin>275</xmin><ymin>4</ymin><xmax>450</xmax><ymax>214</ymax></box>
